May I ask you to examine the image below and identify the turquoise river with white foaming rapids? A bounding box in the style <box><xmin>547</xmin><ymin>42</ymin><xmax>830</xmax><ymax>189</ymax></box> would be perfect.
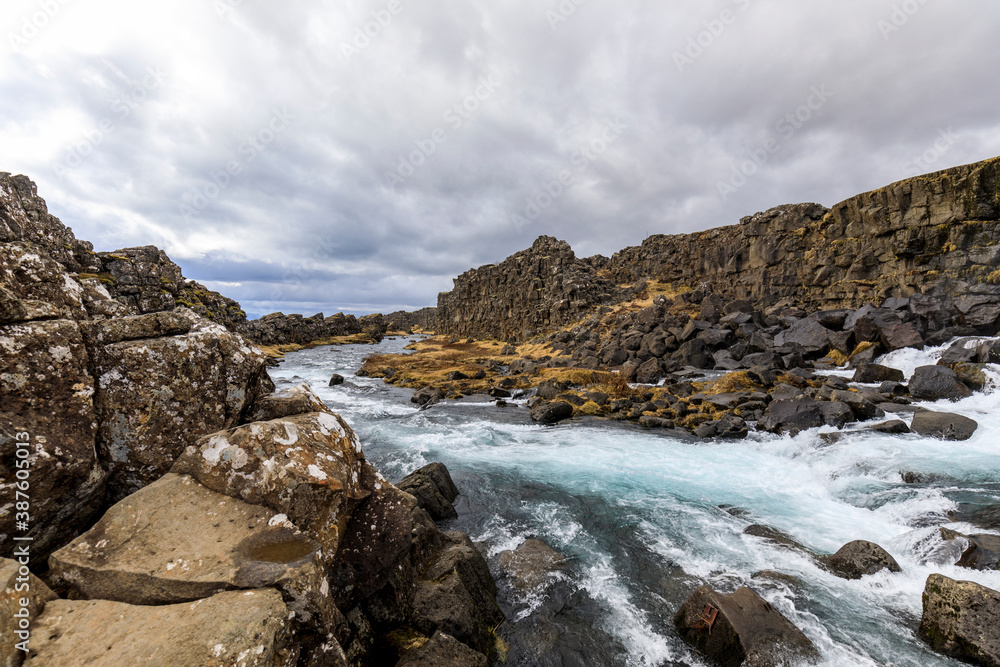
<box><xmin>272</xmin><ymin>339</ymin><xmax>1000</xmax><ymax>667</ymax></box>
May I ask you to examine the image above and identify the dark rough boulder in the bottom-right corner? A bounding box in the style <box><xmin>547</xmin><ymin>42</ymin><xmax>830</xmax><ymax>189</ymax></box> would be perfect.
<box><xmin>919</xmin><ymin>574</ymin><xmax>1000</xmax><ymax>667</ymax></box>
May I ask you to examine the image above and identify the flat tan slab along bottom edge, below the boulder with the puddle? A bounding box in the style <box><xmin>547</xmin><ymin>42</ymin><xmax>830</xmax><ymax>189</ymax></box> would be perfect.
<box><xmin>25</xmin><ymin>589</ymin><xmax>296</xmax><ymax>667</ymax></box>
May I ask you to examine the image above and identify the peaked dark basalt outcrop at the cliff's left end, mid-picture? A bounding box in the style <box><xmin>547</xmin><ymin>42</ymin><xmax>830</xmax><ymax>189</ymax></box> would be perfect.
<box><xmin>437</xmin><ymin>236</ymin><xmax>624</xmax><ymax>340</ymax></box>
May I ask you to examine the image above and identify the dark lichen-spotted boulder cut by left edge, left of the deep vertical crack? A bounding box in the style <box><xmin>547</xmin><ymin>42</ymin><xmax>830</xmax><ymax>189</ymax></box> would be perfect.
<box><xmin>0</xmin><ymin>320</ymin><xmax>107</xmax><ymax>558</ymax></box>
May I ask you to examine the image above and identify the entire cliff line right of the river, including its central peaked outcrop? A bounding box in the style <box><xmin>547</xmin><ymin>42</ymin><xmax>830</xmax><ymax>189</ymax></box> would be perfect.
<box><xmin>437</xmin><ymin>158</ymin><xmax>1000</xmax><ymax>339</ymax></box>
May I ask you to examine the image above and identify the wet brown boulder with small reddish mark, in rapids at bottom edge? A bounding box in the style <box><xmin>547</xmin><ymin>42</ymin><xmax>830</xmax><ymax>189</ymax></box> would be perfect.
<box><xmin>674</xmin><ymin>586</ymin><xmax>819</xmax><ymax>667</ymax></box>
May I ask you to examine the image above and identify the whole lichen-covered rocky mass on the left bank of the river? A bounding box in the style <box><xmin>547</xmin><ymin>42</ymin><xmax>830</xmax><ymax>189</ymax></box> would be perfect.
<box><xmin>0</xmin><ymin>174</ymin><xmax>503</xmax><ymax>667</ymax></box>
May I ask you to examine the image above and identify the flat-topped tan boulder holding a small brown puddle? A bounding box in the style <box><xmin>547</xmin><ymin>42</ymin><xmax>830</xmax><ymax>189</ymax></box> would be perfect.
<box><xmin>49</xmin><ymin>474</ymin><xmax>340</xmax><ymax>640</ymax></box>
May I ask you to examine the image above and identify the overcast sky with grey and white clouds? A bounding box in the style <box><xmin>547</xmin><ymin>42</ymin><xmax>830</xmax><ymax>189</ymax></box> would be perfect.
<box><xmin>0</xmin><ymin>0</ymin><xmax>1000</xmax><ymax>315</ymax></box>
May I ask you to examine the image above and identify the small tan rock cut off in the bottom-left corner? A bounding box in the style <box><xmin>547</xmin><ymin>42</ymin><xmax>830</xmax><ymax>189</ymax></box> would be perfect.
<box><xmin>0</xmin><ymin>560</ymin><xmax>58</xmax><ymax>667</ymax></box>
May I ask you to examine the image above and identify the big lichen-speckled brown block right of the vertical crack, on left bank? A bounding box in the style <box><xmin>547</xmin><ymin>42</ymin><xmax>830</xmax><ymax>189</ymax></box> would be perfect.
<box><xmin>91</xmin><ymin>313</ymin><xmax>273</xmax><ymax>501</ymax></box>
